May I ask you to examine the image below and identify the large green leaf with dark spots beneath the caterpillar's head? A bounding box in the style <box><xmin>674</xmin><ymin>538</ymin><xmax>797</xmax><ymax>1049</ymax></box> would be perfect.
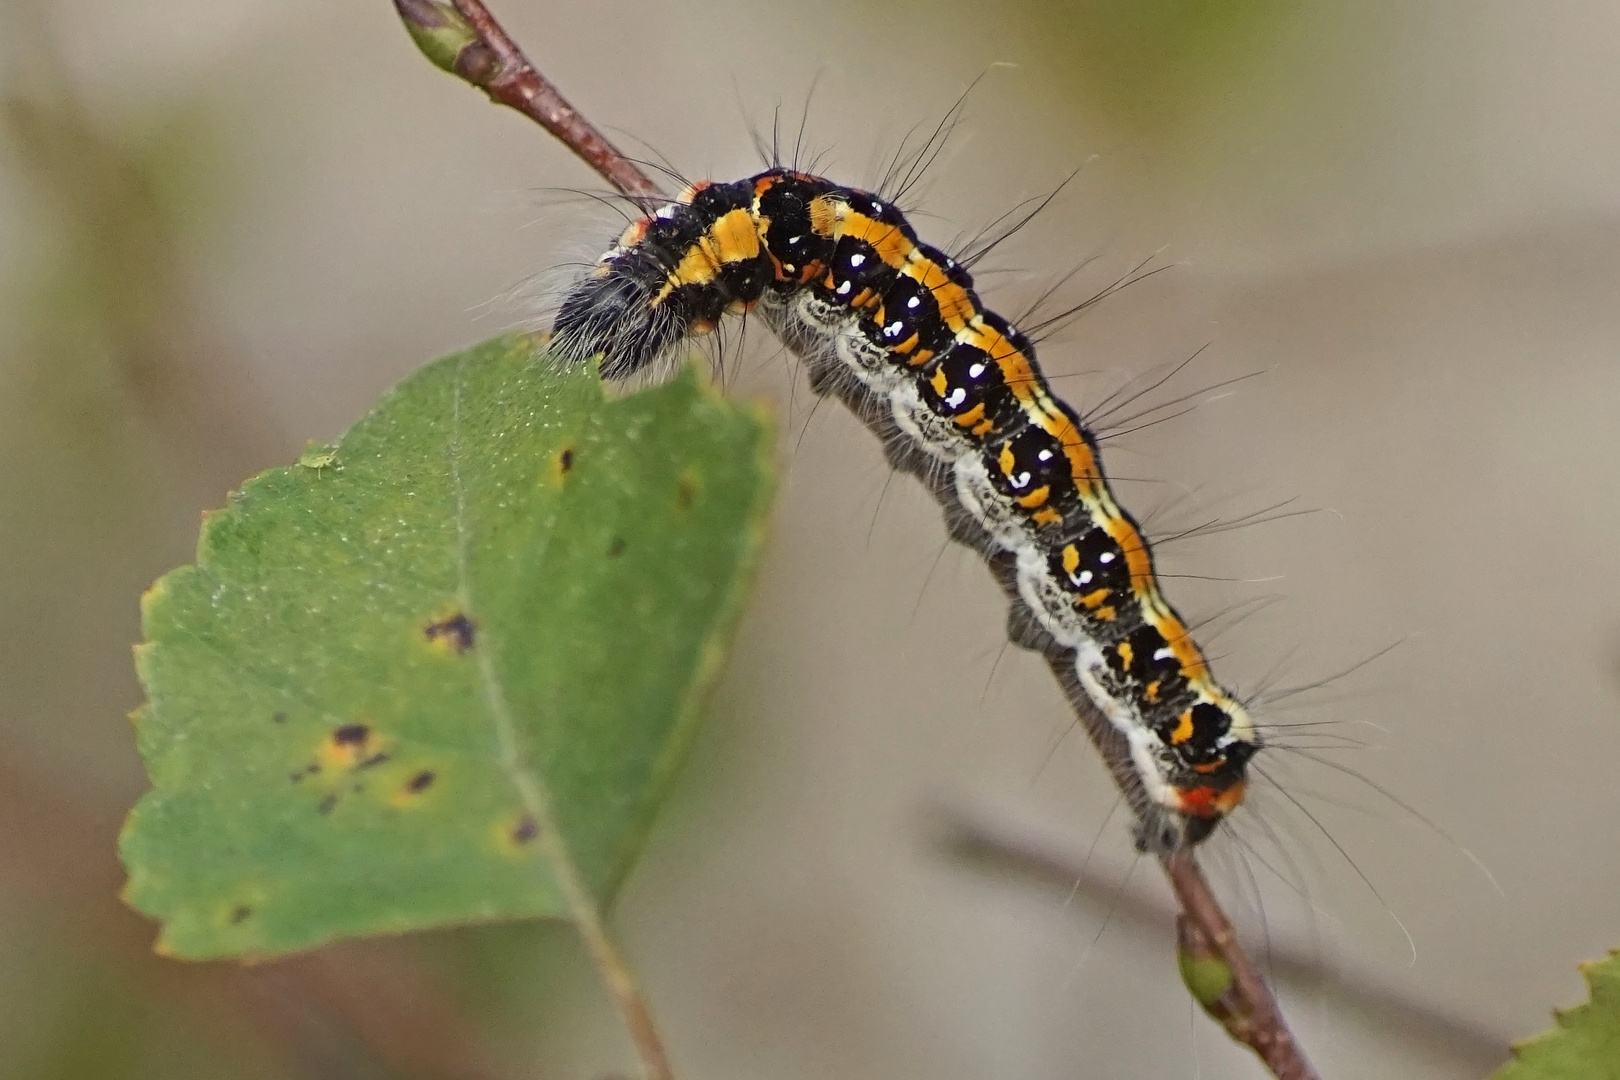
<box><xmin>122</xmin><ymin>338</ymin><xmax>773</xmax><ymax>959</ymax></box>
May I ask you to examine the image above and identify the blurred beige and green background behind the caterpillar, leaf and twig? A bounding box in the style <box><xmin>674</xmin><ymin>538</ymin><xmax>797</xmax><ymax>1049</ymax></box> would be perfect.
<box><xmin>0</xmin><ymin>0</ymin><xmax>1620</xmax><ymax>1080</ymax></box>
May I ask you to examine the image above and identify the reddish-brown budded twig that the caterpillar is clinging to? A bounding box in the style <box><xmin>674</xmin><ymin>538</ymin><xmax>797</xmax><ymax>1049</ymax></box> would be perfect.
<box><xmin>394</xmin><ymin>0</ymin><xmax>1317</xmax><ymax>1080</ymax></box>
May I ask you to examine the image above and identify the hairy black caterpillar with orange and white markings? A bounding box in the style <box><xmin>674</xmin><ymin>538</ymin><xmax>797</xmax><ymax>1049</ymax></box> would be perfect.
<box><xmin>552</xmin><ymin>168</ymin><xmax>1260</xmax><ymax>850</ymax></box>
